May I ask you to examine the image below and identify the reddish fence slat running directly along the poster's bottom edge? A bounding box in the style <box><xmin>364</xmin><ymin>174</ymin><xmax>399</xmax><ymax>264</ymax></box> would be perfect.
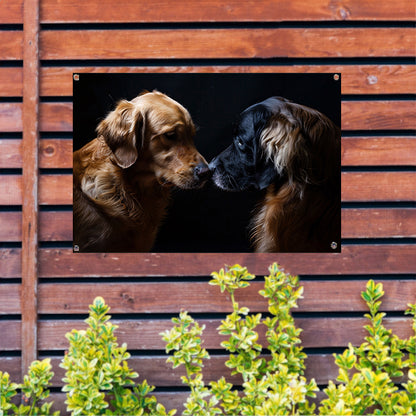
<box><xmin>0</xmin><ymin>244</ymin><xmax>415</xmax><ymax>278</ymax></box>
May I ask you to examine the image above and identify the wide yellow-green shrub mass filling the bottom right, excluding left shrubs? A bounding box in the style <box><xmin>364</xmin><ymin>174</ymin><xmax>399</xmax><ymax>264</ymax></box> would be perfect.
<box><xmin>161</xmin><ymin>264</ymin><xmax>416</xmax><ymax>416</ymax></box>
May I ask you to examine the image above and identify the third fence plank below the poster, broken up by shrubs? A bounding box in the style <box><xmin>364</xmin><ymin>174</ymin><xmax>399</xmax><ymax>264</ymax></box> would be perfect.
<box><xmin>36</xmin><ymin>317</ymin><xmax>412</xmax><ymax>351</ymax></box>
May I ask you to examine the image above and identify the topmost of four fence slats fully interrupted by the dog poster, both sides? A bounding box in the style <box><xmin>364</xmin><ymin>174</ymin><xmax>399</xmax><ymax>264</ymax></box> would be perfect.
<box><xmin>0</xmin><ymin>101</ymin><xmax>416</xmax><ymax>132</ymax></box>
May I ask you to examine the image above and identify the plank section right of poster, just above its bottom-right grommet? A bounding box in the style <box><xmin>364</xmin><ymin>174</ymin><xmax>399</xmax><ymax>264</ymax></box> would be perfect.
<box><xmin>341</xmin><ymin>208</ymin><xmax>416</xmax><ymax>238</ymax></box>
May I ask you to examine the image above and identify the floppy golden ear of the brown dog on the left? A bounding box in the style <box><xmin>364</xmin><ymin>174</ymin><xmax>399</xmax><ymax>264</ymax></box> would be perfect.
<box><xmin>97</xmin><ymin>100</ymin><xmax>144</xmax><ymax>169</ymax></box>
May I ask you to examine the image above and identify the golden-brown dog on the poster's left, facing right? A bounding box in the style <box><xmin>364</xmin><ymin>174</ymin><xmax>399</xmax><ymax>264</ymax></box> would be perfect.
<box><xmin>73</xmin><ymin>91</ymin><xmax>208</xmax><ymax>252</ymax></box>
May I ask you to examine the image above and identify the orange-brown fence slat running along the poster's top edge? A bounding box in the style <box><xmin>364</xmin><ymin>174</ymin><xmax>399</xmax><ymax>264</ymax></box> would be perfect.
<box><xmin>35</xmin><ymin>65</ymin><xmax>416</xmax><ymax>97</ymax></box>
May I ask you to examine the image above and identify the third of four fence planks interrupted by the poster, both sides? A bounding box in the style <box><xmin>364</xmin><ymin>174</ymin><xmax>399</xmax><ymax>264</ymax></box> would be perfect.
<box><xmin>0</xmin><ymin>171</ymin><xmax>416</xmax><ymax>205</ymax></box>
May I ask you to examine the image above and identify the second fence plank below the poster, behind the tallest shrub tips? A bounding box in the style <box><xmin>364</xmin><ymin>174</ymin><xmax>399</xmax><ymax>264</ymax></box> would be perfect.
<box><xmin>39</xmin><ymin>279</ymin><xmax>416</xmax><ymax>314</ymax></box>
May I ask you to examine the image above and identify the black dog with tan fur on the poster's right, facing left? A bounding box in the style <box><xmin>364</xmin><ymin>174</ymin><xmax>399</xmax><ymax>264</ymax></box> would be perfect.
<box><xmin>210</xmin><ymin>97</ymin><xmax>341</xmax><ymax>252</ymax></box>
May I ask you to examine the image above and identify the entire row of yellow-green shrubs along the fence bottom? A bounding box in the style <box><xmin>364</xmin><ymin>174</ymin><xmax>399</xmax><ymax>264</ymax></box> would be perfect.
<box><xmin>0</xmin><ymin>264</ymin><xmax>416</xmax><ymax>416</ymax></box>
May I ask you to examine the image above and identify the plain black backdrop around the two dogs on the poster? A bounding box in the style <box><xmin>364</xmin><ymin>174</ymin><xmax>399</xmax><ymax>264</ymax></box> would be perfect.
<box><xmin>73</xmin><ymin>73</ymin><xmax>341</xmax><ymax>252</ymax></box>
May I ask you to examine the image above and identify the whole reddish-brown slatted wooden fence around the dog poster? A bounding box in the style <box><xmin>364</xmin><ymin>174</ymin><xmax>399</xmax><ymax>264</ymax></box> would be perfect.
<box><xmin>0</xmin><ymin>0</ymin><xmax>416</xmax><ymax>409</ymax></box>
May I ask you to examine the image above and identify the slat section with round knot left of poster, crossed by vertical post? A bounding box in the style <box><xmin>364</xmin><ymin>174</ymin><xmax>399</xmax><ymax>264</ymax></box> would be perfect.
<box><xmin>0</xmin><ymin>139</ymin><xmax>72</xmax><ymax>169</ymax></box>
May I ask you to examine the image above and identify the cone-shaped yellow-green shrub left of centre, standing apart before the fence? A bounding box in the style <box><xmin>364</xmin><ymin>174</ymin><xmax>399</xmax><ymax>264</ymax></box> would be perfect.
<box><xmin>61</xmin><ymin>297</ymin><xmax>174</xmax><ymax>416</ymax></box>
